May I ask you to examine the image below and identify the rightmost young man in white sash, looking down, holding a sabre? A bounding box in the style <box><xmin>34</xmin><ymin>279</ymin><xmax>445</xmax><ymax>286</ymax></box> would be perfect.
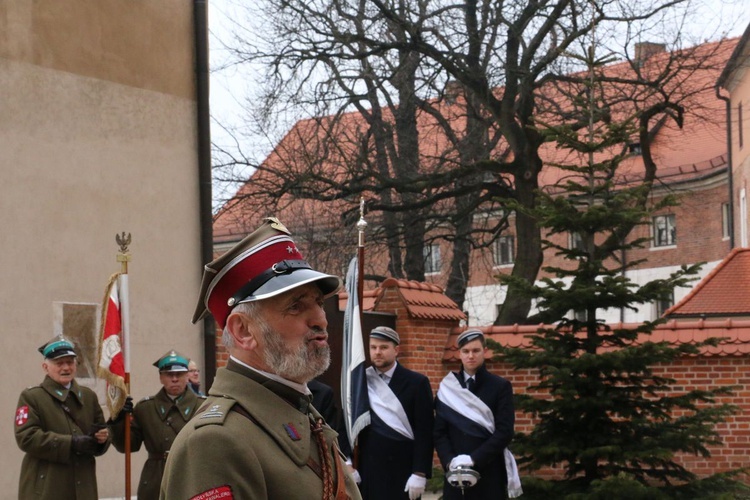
<box><xmin>435</xmin><ymin>329</ymin><xmax>515</xmax><ymax>500</ymax></box>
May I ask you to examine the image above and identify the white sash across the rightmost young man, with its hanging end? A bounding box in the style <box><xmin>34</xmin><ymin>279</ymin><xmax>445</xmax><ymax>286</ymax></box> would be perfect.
<box><xmin>437</xmin><ymin>373</ymin><xmax>523</xmax><ymax>498</ymax></box>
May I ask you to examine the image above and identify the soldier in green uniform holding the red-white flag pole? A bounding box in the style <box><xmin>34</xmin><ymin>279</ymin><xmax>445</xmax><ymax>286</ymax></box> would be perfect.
<box><xmin>108</xmin><ymin>351</ymin><xmax>206</xmax><ymax>500</ymax></box>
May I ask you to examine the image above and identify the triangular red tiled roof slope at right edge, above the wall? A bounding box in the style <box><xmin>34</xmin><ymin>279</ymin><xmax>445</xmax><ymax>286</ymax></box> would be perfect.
<box><xmin>664</xmin><ymin>248</ymin><xmax>750</xmax><ymax>318</ymax></box>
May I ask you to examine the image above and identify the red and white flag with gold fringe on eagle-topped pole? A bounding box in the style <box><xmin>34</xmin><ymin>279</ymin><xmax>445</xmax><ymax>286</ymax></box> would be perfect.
<box><xmin>97</xmin><ymin>273</ymin><xmax>127</xmax><ymax>418</ymax></box>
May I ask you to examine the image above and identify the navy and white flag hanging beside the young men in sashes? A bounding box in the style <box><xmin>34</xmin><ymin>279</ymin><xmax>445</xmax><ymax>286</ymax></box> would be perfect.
<box><xmin>341</xmin><ymin>257</ymin><xmax>370</xmax><ymax>449</ymax></box>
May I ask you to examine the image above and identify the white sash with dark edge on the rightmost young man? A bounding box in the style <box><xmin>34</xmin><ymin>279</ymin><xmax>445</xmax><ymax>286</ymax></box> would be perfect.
<box><xmin>435</xmin><ymin>373</ymin><xmax>523</xmax><ymax>498</ymax></box>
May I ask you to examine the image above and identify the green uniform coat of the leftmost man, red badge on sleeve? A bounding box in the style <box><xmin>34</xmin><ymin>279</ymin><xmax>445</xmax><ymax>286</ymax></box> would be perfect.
<box><xmin>14</xmin><ymin>377</ymin><xmax>109</xmax><ymax>500</ymax></box>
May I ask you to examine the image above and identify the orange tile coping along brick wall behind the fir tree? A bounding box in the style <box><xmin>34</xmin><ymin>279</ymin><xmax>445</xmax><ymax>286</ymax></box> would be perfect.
<box><xmin>443</xmin><ymin>319</ymin><xmax>750</xmax><ymax>361</ymax></box>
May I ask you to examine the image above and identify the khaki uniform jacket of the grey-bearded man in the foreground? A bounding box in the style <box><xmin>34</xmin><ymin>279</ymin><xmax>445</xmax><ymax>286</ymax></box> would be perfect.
<box><xmin>160</xmin><ymin>359</ymin><xmax>361</xmax><ymax>500</ymax></box>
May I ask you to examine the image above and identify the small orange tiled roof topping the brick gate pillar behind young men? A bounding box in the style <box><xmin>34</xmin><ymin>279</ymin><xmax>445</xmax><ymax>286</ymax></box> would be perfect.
<box><xmin>378</xmin><ymin>278</ymin><xmax>466</xmax><ymax>320</ymax></box>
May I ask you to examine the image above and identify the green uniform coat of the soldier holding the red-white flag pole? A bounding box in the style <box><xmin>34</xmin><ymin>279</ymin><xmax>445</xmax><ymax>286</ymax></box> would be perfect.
<box><xmin>109</xmin><ymin>387</ymin><xmax>206</xmax><ymax>500</ymax></box>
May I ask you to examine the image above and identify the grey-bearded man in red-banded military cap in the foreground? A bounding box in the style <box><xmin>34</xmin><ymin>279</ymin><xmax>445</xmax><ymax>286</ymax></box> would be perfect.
<box><xmin>161</xmin><ymin>218</ymin><xmax>360</xmax><ymax>500</ymax></box>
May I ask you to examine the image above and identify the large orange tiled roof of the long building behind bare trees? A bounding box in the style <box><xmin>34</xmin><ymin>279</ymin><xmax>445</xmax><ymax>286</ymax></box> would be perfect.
<box><xmin>213</xmin><ymin>39</ymin><xmax>739</xmax><ymax>242</ymax></box>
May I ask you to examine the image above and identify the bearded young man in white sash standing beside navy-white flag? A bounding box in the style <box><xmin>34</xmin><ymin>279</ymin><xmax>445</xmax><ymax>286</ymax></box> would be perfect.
<box><xmin>357</xmin><ymin>326</ymin><xmax>433</xmax><ymax>500</ymax></box>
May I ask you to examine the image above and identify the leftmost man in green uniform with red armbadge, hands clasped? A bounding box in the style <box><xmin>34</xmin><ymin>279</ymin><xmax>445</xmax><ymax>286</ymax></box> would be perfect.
<box><xmin>15</xmin><ymin>336</ymin><xmax>109</xmax><ymax>500</ymax></box>
